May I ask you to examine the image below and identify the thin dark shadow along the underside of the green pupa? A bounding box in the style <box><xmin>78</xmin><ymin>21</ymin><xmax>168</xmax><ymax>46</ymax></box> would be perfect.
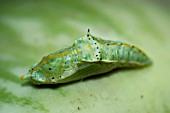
<box><xmin>22</xmin><ymin>67</ymin><xmax>150</xmax><ymax>89</ymax></box>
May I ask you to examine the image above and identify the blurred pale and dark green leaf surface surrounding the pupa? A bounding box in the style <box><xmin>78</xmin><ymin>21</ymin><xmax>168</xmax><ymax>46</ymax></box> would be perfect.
<box><xmin>0</xmin><ymin>0</ymin><xmax>170</xmax><ymax>113</ymax></box>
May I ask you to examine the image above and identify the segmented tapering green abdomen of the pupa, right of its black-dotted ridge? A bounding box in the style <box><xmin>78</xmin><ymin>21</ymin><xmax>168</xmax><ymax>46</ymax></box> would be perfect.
<box><xmin>100</xmin><ymin>42</ymin><xmax>151</xmax><ymax>66</ymax></box>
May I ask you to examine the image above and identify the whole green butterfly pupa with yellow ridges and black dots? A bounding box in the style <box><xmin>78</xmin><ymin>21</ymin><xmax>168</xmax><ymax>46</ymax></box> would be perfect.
<box><xmin>21</xmin><ymin>29</ymin><xmax>152</xmax><ymax>84</ymax></box>
